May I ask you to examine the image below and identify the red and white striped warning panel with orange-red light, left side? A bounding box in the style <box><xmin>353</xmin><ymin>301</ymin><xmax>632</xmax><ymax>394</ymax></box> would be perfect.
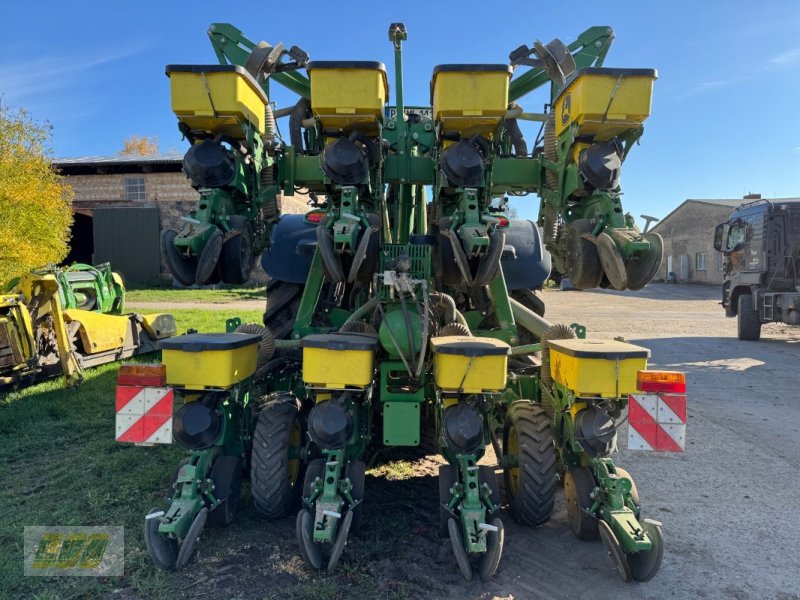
<box><xmin>115</xmin><ymin>365</ymin><xmax>175</xmax><ymax>446</ymax></box>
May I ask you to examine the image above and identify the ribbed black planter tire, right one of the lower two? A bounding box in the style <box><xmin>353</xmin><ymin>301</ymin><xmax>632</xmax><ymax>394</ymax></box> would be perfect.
<box><xmin>503</xmin><ymin>400</ymin><xmax>558</xmax><ymax>527</ymax></box>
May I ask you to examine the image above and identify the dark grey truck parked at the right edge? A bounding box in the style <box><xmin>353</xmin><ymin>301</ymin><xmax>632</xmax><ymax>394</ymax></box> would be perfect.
<box><xmin>714</xmin><ymin>199</ymin><xmax>800</xmax><ymax>340</ymax></box>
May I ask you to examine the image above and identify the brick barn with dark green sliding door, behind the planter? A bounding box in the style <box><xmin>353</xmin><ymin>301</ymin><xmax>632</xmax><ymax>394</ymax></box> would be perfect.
<box><xmin>54</xmin><ymin>154</ymin><xmax>307</xmax><ymax>283</ymax></box>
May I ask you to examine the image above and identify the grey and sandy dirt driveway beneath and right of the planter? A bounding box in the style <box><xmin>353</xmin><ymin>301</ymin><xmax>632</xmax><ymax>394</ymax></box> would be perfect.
<box><xmin>147</xmin><ymin>284</ymin><xmax>800</xmax><ymax>600</ymax></box>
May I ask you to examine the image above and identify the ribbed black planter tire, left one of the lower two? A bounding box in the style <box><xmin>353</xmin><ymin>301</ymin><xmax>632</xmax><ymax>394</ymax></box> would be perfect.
<box><xmin>250</xmin><ymin>402</ymin><xmax>303</xmax><ymax>519</ymax></box>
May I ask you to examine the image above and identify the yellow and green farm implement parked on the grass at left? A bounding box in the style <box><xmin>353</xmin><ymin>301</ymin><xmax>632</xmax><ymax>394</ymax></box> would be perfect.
<box><xmin>0</xmin><ymin>263</ymin><xmax>176</xmax><ymax>386</ymax></box>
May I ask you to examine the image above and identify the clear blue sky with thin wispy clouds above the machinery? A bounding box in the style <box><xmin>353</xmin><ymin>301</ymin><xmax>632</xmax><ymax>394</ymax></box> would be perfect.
<box><xmin>0</xmin><ymin>0</ymin><xmax>800</xmax><ymax>223</ymax></box>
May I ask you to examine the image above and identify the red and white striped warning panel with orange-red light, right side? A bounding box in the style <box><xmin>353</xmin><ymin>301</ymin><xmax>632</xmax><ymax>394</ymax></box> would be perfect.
<box><xmin>628</xmin><ymin>371</ymin><xmax>686</xmax><ymax>452</ymax></box>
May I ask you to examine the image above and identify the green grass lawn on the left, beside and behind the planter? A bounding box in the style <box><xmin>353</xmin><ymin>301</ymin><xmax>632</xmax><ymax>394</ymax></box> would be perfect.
<box><xmin>0</xmin><ymin>310</ymin><xmax>261</xmax><ymax>598</ymax></box>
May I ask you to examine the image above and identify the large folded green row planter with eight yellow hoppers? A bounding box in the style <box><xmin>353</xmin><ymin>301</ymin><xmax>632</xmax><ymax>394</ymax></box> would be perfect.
<box><xmin>123</xmin><ymin>23</ymin><xmax>685</xmax><ymax>581</ymax></box>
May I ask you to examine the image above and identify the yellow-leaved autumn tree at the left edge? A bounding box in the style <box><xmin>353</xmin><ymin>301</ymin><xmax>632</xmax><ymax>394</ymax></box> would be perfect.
<box><xmin>0</xmin><ymin>107</ymin><xmax>73</xmax><ymax>283</ymax></box>
